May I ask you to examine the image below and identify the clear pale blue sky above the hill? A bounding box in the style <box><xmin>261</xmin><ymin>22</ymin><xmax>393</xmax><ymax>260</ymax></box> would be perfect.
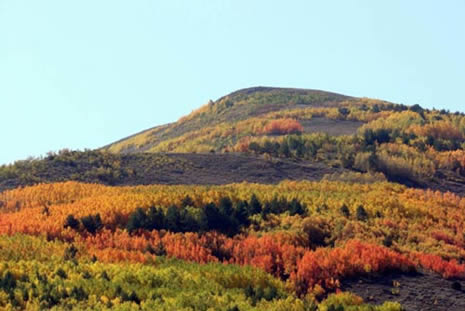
<box><xmin>0</xmin><ymin>0</ymin><xmax>465</xmax><ymax>164</ymax></box>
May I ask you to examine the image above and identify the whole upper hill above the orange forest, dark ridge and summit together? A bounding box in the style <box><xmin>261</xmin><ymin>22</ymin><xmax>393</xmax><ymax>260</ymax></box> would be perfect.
<box><xmin>5</xmin><ymin>87</ymin><xmax>465</xmax><ymax>194</ymax></box>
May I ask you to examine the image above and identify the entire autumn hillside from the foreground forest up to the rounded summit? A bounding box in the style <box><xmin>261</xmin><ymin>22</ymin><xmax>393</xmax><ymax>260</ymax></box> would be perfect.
<box><xmin>0</xmin><ymin>87</ymin><xmax>465</xmax><ymax>311</ymax></box>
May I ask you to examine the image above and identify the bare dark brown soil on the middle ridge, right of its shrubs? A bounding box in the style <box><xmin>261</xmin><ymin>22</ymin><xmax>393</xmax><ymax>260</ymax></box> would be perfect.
<box><xmin>123</xmin><ymin>153</ymin><xmax>343</xmax><ymax>185</ymax></box>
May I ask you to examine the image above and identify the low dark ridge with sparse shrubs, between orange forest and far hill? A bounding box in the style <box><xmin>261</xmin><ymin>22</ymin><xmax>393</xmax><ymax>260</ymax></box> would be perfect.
<box><xmin>0</xmin><ymin>150</ymin><xmax>348</xmax><ymax>192</ymax></box>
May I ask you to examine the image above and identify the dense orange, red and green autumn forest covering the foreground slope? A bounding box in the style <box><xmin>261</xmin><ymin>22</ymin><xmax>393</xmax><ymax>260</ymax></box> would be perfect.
<box><xmin>0</xmin><ymin>181</ymin><xmax>465</xmax><ymax>310</ymax></box>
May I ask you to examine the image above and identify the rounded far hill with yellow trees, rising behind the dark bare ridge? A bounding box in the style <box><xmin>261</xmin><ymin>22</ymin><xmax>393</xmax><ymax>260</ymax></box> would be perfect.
<box><xmin>105</xmin><ymin>88</ymin><xmax>465</xmax><ymax>192</ymax></box>
